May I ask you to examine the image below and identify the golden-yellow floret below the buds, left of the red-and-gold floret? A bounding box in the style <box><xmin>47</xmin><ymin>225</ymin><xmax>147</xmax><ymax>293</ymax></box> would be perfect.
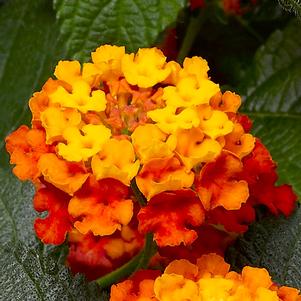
<box><xmin>91</xmin><ymin>138</ymin><xmax>140</xmax><ymax>185</ymax></box>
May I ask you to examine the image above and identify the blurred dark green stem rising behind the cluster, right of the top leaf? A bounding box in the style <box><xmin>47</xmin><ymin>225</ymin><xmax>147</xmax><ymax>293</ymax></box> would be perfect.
<box><xmin>177</xmin><ymin>9</ymin><xmax>205</xmax><ymax>63</ymax></box>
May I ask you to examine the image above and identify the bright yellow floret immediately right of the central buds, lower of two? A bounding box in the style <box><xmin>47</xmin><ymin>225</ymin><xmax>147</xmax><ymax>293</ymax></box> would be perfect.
<box><xmin>147</xmin><ymin>107</ymin><xmax>200</xmax><ymax>134</ymax></box>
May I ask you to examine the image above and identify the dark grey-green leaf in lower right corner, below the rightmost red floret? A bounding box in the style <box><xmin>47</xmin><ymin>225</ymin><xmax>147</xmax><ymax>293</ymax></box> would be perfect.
<box><xmin>227</xmin><ymin>208</ymin><xmax>301</xmax><ymax>289</ymax></box>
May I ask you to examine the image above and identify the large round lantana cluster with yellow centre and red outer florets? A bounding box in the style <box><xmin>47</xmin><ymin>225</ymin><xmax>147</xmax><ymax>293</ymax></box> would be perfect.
<box><xmin>6</xmin><ymin>45</ymin><xmax>296</xmax><ymax>288</ymax></box>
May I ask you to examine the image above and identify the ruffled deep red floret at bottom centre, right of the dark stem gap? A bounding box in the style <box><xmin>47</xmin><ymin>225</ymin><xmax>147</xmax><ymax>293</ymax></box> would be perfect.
<box><xmin>138</xmin><ymin>189</ymin><xmax>204</xmax><ymax>247</ymax></box>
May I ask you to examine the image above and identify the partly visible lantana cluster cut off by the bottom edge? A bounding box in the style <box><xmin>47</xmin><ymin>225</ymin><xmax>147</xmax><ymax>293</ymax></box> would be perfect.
<box><xmin>110</xmin><ymin>253</ymin><xmax>301</xmax><ymax>301</ymax></box>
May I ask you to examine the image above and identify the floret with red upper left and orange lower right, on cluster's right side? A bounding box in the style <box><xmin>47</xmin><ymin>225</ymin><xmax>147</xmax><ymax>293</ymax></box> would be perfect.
<box><xmin>195</xmin><ymin>151</ymin><xmax>249</xmax><ymax>210</ymax></box>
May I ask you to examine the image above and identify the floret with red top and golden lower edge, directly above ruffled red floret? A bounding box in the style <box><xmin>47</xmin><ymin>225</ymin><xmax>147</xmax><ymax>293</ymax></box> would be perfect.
<box><xmin>136</xmin><ymin>157</ymin><xmax>194</xmax><ymax>200</ymax></box>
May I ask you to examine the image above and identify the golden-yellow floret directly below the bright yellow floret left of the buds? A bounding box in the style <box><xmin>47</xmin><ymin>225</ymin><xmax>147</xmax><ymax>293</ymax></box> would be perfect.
<box><xmin>41</xmin><ymin>107</ymin><xmax>81</xmax><ymax>144</ymax></box>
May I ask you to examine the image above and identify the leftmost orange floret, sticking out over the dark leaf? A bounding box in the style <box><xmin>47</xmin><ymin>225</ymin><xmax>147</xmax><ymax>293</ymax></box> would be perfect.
<box><xmin>5</xmin><ymin>125</ymin><xmax>51</xmax><ymax>181</ymax></box>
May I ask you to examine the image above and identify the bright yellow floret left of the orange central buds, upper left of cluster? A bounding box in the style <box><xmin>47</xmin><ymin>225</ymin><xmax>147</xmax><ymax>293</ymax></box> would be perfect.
<box><xmin>49</xmin><ymin>80</ymin><xmax>106</xmax><ymax>113</ymax></box>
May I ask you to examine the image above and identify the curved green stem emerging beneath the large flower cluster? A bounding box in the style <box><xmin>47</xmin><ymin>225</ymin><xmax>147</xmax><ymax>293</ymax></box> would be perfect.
<box><xmin>96</xmin><ymin>234</ymin><xmax>154</xmax><ymax>288</ymax></box>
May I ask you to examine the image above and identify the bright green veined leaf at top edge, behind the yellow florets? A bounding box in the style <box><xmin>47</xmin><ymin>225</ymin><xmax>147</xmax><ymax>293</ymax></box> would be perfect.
<box><xmin>54</xmin><ymin>0</ymin><xmax>186</xmax><ymax>60</ymax></box>
